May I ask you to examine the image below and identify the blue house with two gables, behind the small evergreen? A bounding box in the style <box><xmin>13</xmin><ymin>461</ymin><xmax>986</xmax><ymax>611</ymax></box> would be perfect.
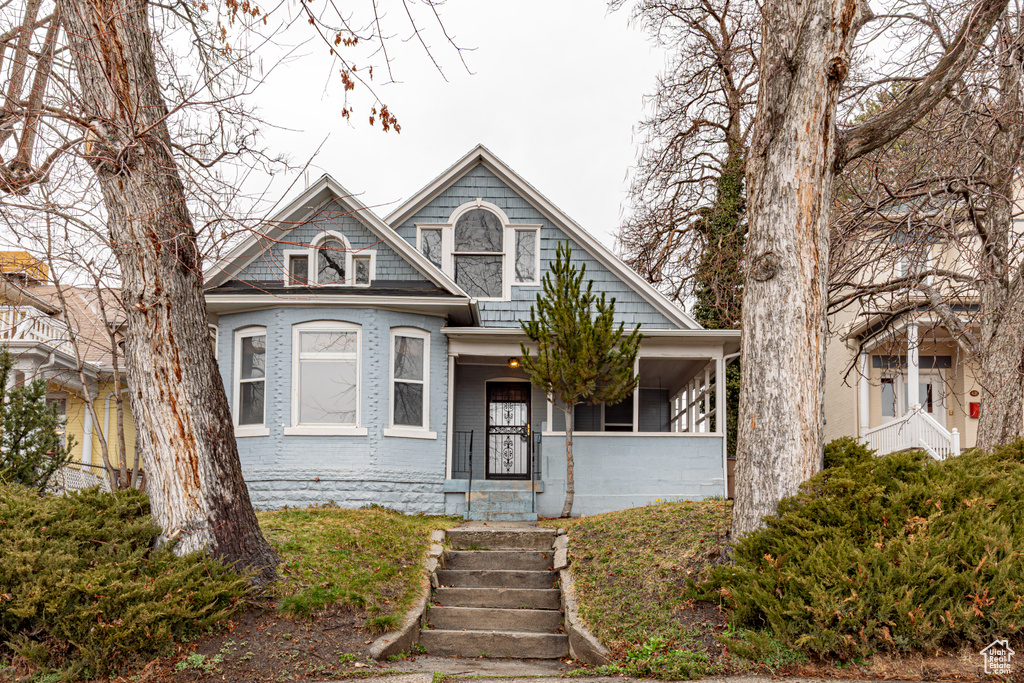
<box><xmin>207</xmin><ymin>147</ymin><xmax>738</xmax><ymax>519</ymax></box>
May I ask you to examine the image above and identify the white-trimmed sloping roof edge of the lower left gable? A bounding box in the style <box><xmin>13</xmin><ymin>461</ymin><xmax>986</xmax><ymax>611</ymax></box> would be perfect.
<box><xmin>204</xmin><ymin>173</ymin><xmax>469</xmax><ymax>298</ymax></box>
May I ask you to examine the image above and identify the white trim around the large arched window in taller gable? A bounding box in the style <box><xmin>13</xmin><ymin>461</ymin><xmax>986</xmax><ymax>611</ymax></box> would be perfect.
<box><xmin>415</xmin><ymin>197</ymin><xmax>542</xmax><ymax>301</ymax></box>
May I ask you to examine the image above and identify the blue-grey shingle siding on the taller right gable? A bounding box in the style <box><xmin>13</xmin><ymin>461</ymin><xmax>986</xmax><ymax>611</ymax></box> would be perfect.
<box><xmin>396</xmin><ymin>165</ymin><xmax>676</xmax><ymax>329</ymax></box>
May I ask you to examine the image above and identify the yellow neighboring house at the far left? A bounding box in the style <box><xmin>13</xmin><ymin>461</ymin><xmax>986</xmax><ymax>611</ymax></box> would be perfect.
<box><xmin>0</xmin><ymin>251</ymin><xmax>135</xmax><ymax>485</ymax></box>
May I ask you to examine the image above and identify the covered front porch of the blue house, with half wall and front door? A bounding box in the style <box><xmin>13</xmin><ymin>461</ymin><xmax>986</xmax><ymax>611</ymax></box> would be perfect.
<box><xmin>444</xmin><ymin>331</ymin><xmax>734</xmax><ymax>520</ymax></box>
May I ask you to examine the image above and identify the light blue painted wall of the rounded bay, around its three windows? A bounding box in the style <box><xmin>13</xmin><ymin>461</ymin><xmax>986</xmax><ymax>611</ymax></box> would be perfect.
<box><xmin>218</xmin><ymin>307</ymin><xmax>447</xmax><ymax>514</ymax></box>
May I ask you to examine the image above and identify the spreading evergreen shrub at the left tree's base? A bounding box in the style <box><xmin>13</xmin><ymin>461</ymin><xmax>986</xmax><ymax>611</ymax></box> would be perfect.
<box><xmin>0</xmin><ymin>485</ymin><xmax>247</xmax><ymax>676</ymax></box>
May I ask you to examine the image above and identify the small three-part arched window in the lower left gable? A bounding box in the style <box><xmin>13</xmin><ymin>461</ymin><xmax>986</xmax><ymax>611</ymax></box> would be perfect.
<box><xmin>284</xmin><ymin>230</ymin><xmax>377</xmax><ymax>287</ymax></box>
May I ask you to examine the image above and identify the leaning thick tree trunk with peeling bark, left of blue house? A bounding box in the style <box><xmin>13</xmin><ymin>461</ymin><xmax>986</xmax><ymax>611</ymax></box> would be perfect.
<box><xmin>58</xmin><ymin>0</ymin><xmax>276</xmax><ymax>583</ymax></box>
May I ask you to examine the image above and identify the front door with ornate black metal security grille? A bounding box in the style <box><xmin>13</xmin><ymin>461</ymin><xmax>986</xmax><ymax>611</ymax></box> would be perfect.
<box><xmin>487</xmin><ymin>382</ymin><xmax>530</xmax><ymax>479</ymax></box>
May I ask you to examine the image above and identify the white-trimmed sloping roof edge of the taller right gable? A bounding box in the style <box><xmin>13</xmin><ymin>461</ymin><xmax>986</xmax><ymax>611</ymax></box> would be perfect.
<box><xmin>384</xmin><ymin>144</ymin><xmax>703</xmax><ymax>330</ymax></box>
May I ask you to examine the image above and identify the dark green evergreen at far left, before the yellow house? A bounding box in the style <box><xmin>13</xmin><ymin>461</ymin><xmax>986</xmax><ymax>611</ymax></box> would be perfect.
<box><xmin>0</xmin><ymin>346</ymin><xmax>75</xmax><ymax>490</ymax></box>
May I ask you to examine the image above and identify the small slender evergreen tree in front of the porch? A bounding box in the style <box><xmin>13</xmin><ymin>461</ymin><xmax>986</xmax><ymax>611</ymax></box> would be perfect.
<box><xmin>519</xmin><ymin>243</ymin><xmax>642</xmax><ymax>517</ymax></box>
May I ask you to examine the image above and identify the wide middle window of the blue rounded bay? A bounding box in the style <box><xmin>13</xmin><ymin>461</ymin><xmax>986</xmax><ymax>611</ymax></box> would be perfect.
<box><xmin>285</xmin><ymin>321</ymin><xmax>367</xmax><ymax>435</ymax></box>
